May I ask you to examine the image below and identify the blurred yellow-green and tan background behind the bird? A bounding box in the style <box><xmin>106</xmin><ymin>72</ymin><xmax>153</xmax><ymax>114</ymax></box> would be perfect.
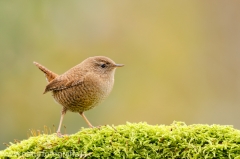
<box><xmin>0</xmin><ymin>0</ymin><xmax>240</xmax><ymax>149</ymax></box>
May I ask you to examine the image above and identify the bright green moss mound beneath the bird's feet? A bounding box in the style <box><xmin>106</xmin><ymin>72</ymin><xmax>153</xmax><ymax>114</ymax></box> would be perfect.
<box><xmin>0</xmin><ymin>122</ymin><xmax>240</xmax><ymax>159</ymax></box>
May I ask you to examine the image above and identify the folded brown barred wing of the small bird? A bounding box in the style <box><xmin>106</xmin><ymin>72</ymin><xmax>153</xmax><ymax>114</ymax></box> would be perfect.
<box><xmin>44</xmin><ymin>72</ymin><xmax>84</xmax><ymax>94</ymax></box>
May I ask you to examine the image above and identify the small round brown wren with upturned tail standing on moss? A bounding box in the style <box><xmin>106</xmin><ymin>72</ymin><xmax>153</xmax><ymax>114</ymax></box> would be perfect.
<box><xmin>33</xmin><ymin>56</ymin><xmax>124</xmax><ymax>136</ymax></box>
